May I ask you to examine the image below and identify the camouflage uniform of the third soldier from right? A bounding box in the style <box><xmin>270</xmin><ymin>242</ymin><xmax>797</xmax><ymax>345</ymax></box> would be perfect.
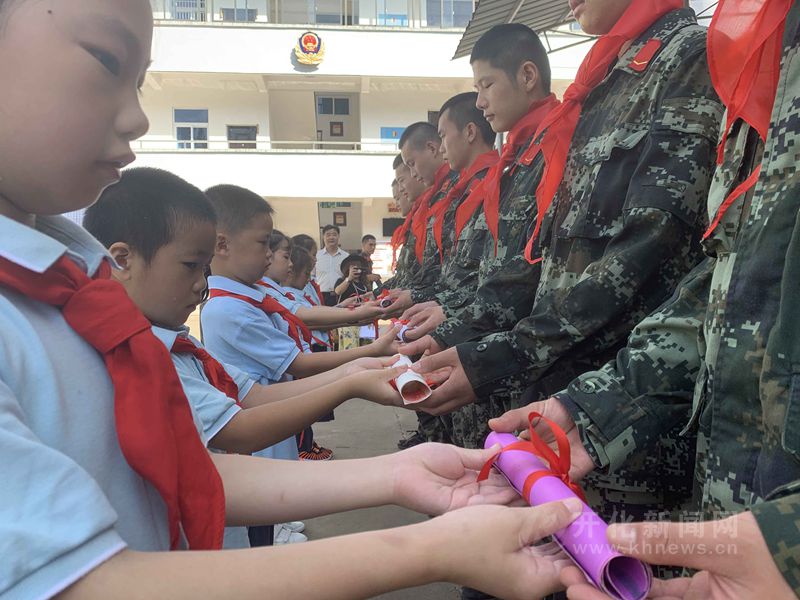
<box><xmin>431</xmin><ymin>140</ymin><xmax>552</xmax><ymax>448</ymax></box>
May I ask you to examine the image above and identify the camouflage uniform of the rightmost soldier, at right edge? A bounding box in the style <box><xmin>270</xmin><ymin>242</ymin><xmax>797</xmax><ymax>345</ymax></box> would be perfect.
<box><xmin>559</xmin><ymin>4</ymin><xmax>800</xmax><ymax>595</ymax></box>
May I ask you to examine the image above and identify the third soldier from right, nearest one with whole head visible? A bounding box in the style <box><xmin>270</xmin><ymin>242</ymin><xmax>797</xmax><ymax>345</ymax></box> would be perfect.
<box><xmin>404</xmin><ymin>24</ymin><xmax>558</xmax><ymax>460</ymax></box>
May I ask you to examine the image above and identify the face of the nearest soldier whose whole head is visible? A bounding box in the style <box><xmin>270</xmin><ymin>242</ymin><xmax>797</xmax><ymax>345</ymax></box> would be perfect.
<box><xmin>472</xmin><ymin>60</ymin><xmax>532</xmax><ymax>133</ymax></box>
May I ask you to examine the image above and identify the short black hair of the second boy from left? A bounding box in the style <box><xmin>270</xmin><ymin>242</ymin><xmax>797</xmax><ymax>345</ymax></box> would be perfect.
<box><xmin>83</xmin><ymin>167</ymin><xmax>217</xmax><ymax>263</ymax></box>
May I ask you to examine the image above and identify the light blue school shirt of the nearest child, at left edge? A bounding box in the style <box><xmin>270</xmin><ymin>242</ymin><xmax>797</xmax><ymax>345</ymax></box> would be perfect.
<box><xmin>0</xmin><ymin>216</ymin><xmax>178</xmax><ymax>600</ymax></box>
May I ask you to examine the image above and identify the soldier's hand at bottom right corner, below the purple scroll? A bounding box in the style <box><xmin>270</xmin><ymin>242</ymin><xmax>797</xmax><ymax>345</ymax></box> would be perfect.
<box><xmin>562</xmin><ymin>512</ymin><xmax>796</xmax><ymax>600</ymax></box>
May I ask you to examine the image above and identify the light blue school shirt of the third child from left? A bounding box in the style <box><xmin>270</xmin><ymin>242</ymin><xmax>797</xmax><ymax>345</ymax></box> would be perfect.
<box><xmin>200</xmin><ymin>275</ymin><xmax>300</xmax><ymax>460</ymax></box>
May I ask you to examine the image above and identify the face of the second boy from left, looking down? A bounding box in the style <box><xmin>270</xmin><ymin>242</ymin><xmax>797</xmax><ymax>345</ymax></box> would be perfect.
<box><xmin>118</xmin><ymin>222</ymin><xmax>217</xmax><ymax>329</ymax></box>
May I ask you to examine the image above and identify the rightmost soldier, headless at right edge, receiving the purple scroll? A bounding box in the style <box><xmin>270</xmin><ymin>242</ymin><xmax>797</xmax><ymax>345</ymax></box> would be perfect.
<box><xmin>492</xmin><ymin>0</ymin><xmax>800</xmax><ymax>599</ymax></box>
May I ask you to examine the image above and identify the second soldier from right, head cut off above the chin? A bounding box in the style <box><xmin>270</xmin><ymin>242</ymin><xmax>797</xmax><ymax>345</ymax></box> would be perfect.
<box><xmin>410</xmin><ymin>0</ymin><xmax>722</xmax><ymax>536</ymax></box>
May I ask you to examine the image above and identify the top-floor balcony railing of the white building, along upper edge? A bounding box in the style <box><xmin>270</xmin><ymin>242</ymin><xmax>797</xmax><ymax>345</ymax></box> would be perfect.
<box><xmin>150</xmin><ymin>0</ymin><xmax>476</xmax><ymax>29</ymax></box>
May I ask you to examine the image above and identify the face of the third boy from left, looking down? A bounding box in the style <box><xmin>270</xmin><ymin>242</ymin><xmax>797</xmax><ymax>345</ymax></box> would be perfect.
<box><xmin>222</xmin><ymin>213</ymin><xmax>272</xmax><ymax>285</ymax></box>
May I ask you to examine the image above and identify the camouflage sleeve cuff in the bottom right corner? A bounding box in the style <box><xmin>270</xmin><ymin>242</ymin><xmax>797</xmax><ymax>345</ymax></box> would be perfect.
<box><xmin>751</xmin><ymin>488</ymin><xmax>800</xmax><ymax>597</ymax></box>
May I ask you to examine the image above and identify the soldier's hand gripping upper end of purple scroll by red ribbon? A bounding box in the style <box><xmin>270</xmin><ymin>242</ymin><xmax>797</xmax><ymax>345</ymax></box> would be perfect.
<box><xmin>489</xmin><ymin>398</ymin><xmax>595</xmax><ymax>481</ymax></box>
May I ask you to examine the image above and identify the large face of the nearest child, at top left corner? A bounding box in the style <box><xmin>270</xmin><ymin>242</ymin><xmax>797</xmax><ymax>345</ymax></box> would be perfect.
<box><xmin>0</xmin><ymin>0</ymin><xmax>153</xmax><ymax>220</ymax></box>
